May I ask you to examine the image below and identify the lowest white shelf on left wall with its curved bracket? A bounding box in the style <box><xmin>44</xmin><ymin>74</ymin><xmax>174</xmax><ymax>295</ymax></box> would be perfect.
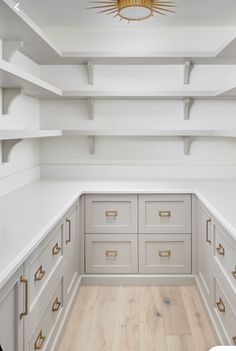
<box><xmin>0</xmin><ymin>129</ymin><xmax>62</xmax><ymax>163</ymax></box>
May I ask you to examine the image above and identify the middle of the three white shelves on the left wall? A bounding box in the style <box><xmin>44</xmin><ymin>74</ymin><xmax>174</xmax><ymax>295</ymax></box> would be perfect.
<box><xmin>0</xmin><ymin>60</ymin><xmax>62</xmax><ymax>98</ymax></box>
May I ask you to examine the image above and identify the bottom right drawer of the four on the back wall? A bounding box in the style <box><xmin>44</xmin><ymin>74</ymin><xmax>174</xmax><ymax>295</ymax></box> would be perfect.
<box><xmin>139</xmin><ymin>234</ymin><xmax>191</xmax><ymax>274</ymax></box>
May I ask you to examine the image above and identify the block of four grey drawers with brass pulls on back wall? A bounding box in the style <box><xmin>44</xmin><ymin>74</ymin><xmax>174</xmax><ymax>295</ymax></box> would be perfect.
<box><xmin>85</xmin><ymin>194</ymin><xmax>192</xmax><ymax>274</ymax></box>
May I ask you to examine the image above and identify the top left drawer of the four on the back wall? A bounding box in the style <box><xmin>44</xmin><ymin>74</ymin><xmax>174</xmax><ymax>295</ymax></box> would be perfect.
<box><xmin>85</xmin><ymin>195</ymin><xmax>137</xmax><ymax>234</ymax></box>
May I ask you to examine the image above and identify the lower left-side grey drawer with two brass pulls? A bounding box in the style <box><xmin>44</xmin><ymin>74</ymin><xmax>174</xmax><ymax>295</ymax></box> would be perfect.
<box><xmin>27</xmin><ymin>279</ymin><xmax>63</xmax><ymax>351</ymax></box>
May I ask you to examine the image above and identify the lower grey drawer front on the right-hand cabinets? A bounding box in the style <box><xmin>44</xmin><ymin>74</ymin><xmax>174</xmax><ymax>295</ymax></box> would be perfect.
<box><xmin>214</xmin><ymin>277</ymin><xmax>236</xmax><ymax>345</ymax></box>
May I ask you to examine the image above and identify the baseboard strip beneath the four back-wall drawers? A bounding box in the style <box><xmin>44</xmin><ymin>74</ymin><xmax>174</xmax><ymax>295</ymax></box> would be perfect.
<box><xmin>82</xmin><ymin>274</ymin><xmax>195</xmax><ymax>286</ymax></box>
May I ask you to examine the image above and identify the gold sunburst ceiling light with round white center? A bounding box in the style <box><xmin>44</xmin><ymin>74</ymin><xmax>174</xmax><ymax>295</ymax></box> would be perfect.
<box><xmin>89</xmin><ymin>0</ymin><xmax>176</xmax><ymax>21</ymax></box>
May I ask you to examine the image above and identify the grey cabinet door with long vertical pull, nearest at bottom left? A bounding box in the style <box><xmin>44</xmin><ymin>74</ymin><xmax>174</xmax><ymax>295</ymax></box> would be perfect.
<box><xmin>0</xmin><ymin>268</ymin><xmax>24</xmax><ymax>351</ymax></box>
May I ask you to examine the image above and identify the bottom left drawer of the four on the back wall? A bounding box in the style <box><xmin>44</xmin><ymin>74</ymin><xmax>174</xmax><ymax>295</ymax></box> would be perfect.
<box><xmin>86</xmin><ymin>234</ymin><xmax>138</xmax><ymax>273</ymax></box>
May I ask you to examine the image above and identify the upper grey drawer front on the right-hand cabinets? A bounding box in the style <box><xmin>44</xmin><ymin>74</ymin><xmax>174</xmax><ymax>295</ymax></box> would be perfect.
<box><xmin>214</xmin><ymin>225</ymin><xmax>236</xmax><ymax>290</ymax></box>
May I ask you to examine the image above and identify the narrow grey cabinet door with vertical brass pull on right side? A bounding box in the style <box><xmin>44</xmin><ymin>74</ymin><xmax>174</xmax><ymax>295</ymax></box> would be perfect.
<box><xmin>198</xmin><ymin>204</ymin><xmax>214</xmax><ymax>302</ymax></box>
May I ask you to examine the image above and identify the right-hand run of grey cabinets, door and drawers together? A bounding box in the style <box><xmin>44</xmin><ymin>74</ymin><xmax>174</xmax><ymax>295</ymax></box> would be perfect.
<box><xmin>197</xmin><ymin>203</ymin><xmax>236</xmax><ymax>345</ymax></box>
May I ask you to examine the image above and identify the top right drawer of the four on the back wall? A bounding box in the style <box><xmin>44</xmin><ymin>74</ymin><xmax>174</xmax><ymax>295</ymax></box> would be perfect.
<box><xmin>139</xmin><ymin>194</ymin><xmax>192</xmax><ymax>234</ymax></box>
